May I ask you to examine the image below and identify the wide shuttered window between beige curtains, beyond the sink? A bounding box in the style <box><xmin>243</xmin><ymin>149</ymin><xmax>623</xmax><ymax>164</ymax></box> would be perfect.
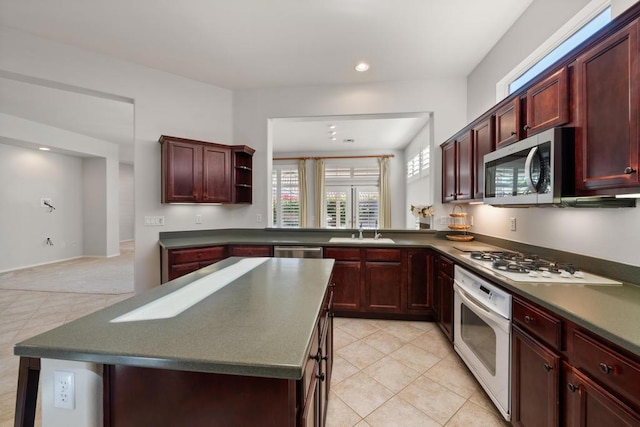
<box><xmin>324</xmin><ymin>164</ymin><xmax>380</xmax><ymax>228</ymax></box>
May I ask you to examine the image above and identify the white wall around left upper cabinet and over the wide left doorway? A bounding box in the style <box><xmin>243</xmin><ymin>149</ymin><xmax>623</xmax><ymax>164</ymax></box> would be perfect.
<box><xmin>0</xmin><ymin>27</ymin><xmax>235</xmax><ymax>291</ymax></box>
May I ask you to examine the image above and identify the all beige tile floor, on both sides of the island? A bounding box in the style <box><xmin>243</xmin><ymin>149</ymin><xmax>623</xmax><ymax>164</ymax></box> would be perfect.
<box><xmin>0</xmin><ymin>290</ymin><xmax>505</xmax><ymax>427</ymax></box>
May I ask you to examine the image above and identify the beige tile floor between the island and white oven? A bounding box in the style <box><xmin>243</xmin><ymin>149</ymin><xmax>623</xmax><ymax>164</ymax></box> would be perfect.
<box><xmin>327</xmin><ymin>318</ymin><xmax>509</xmax><ymax>427</ymax></box>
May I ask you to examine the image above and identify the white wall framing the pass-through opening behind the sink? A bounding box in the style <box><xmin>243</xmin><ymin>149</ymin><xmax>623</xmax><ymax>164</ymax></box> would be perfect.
<box><xmin>233</xmin><ymin>78</ymin><xmax>466</xmax><ymax>232</ymax></box>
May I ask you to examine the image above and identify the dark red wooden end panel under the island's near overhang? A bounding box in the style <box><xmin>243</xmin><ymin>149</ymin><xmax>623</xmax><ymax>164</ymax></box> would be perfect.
<box><xmin>104</xmin><ymin>365</ymin><xmax>296</xmax><ymax>427</ymax></box>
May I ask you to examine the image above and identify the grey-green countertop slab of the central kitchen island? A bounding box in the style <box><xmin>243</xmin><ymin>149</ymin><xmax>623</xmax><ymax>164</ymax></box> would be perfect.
<box><xmin>14</xmin><ymin>257</ymin><xmax>334</xmax><ymax>379</ymax></box>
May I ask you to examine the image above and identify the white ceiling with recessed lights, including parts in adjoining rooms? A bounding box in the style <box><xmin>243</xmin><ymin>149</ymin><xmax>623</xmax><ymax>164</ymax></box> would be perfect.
<box><xmin>0</xmin><ymin>0</ymin><xmax>533</xmax><ymax>152</ymax></box>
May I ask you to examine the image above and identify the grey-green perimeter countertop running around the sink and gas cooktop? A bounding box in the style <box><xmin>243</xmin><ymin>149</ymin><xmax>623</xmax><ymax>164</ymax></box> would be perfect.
<box><xmin>160</xmin><ymin>229</ymin><xmax>640</xmax><ymax>356</ymax></box>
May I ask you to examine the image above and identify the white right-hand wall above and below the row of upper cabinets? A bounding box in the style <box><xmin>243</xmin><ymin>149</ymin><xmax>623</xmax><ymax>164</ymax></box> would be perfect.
<box><xmin>468</xmin><ymin>0</ymin><xmax>640</xmax><ymax>265</ymax></box>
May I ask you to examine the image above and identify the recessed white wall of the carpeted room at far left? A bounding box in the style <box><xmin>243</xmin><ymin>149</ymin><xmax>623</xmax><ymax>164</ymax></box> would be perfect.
<box><xmin>0</xmin><ymin>143</ymin><xmax>83</xmax><ymax>271</ymax></box>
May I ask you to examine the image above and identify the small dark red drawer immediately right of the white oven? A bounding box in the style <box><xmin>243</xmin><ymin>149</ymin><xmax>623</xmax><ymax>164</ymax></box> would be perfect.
<box><xmin>513</xmin><ymin>297</ymin><xmax>562</xmax><ymax>350</ymax></box>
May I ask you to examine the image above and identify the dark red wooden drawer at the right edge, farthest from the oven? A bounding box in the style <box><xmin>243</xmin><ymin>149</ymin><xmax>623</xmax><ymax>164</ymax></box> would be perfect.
<box><xmin>569</xmin><ymin>329</ymin><xmax>640</xmax><ymax>407</ymax></box>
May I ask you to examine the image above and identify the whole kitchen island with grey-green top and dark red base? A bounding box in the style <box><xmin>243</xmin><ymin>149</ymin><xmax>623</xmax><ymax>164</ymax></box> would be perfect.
<box><xmin>14</xmin><ymin>258</ymin><xmax>333</xmax><ymax>426</ymax></box>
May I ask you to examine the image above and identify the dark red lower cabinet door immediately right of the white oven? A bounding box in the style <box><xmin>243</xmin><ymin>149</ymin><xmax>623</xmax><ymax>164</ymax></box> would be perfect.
<box><xmin>511</xmin><ymin>326</ymin><xmax>560</xmax><ymax>426</ymax></box>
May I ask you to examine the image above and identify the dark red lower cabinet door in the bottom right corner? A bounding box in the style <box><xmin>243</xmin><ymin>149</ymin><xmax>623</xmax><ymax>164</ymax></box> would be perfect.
<box><xmin>562</xmin><ymin>362</ymin><xmax>640</xmax><ymax>427</ymax></box>
